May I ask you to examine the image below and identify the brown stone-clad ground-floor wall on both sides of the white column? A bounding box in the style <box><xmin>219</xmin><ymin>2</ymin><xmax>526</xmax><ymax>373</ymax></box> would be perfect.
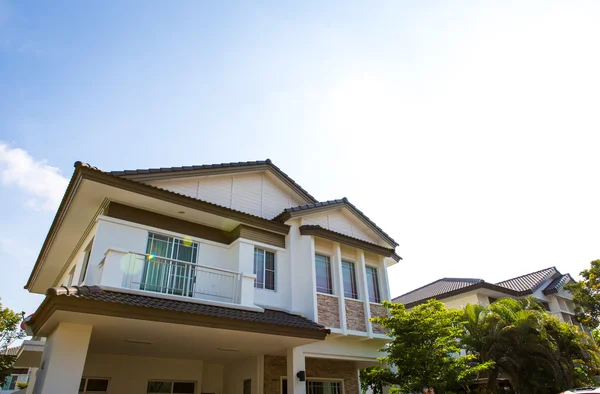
<box><xmin>264</xmin><ymin>356</ymin><xmax>359</xmax><ymax>394</ymax></box>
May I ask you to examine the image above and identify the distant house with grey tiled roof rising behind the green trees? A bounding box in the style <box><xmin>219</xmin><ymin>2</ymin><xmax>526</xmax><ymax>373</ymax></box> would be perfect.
<box><xmin>393</xmin><ymin>267</ymin><xmax>579</xmax><ymax>325</ymax></box>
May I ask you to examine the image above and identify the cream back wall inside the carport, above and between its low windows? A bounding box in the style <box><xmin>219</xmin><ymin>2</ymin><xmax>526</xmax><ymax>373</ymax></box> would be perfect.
<box><xmin>83</xmin><ymin>353</ymin><xmax>204</xmax><ymax>394</ymax></box>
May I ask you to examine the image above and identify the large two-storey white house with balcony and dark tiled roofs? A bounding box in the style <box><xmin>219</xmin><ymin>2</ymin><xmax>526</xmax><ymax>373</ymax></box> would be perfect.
<box><xmin>25</xmin><ymin>160</ymin><xmax>400</xmax><ymax>394</ymax></box>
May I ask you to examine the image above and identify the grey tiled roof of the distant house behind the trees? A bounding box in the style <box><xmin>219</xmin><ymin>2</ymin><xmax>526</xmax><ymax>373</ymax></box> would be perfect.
<box><xmin>393</xmin><ymin>267</ymin><xmax>574</xmax><ymax>308</ymax></box>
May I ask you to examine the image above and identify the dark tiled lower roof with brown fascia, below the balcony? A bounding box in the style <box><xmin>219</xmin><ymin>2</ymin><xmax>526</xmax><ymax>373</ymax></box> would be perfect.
<box><xmin>27</xmin><ymin>286</ymin><xmax>330</xmax><ymax>340</ymax></box>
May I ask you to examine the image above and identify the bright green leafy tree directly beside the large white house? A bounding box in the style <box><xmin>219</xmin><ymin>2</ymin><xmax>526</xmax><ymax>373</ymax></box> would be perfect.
<box><xmin>361</xmin><ymin>300</ymin><xmax>491</xmax><ymax>393</ymax></box>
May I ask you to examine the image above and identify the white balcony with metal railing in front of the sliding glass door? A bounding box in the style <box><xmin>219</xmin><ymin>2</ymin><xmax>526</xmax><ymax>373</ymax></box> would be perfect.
<box><xmin>99</xmin><ymin>249</ymin><xmax>256</xmax><ymax>307</ymax></box>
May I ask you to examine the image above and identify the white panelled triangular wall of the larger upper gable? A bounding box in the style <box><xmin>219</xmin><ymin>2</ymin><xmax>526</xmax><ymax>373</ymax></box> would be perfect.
<box><xmin>147</xmin><ymin>172</ymin><xmax>306</xmax><ymax>219</ymax></box>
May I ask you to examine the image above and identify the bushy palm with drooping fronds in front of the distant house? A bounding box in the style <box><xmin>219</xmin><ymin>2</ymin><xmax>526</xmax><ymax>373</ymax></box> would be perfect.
<box><xmin>462</xmin><ymin>298</ymin><xmax>600</xmax><ymax>394</ymax></box>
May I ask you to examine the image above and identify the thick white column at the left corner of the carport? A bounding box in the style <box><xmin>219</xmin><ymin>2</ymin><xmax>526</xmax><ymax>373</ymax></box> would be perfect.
<box><xmin>33</xmin><ymin>323</ymin><xmax>92</xmax><ymax>394</ymax></box>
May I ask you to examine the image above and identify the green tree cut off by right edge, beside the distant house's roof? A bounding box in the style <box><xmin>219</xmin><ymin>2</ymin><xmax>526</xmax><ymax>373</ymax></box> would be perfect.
<box><xmin>566</xmin><ymin>260</ymin><xmax>600</xmax><ymax>329</ymax></box>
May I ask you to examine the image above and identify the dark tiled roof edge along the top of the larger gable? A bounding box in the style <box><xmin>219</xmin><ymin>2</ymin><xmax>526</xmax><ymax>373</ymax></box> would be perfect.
<box><xmin>110</xmin><ymin>159</ymin><xmax>317</xmax><ymax>203</ymax></box>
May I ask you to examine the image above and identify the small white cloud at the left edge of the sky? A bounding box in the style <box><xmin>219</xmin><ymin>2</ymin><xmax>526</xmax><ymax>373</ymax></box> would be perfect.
<box><xmin>0</xmin><ymin>142</ymin><xmax>68</xmax><ymax>210</ymax></box>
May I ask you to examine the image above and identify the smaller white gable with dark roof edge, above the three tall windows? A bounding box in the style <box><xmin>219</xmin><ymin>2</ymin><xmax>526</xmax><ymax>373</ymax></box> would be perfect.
<box><xmin>273</xmin><ymin>197</ymin><xmax>398</xmax><ymax>248</ymax></box>
